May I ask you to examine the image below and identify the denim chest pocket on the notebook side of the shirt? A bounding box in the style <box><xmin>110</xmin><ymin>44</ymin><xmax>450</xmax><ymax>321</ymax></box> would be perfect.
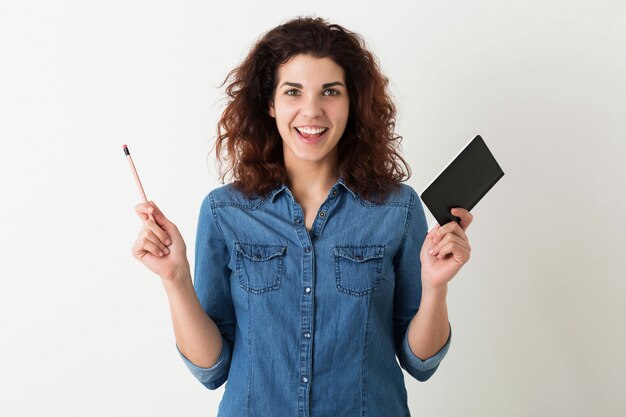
<box><xmin>333</xmin><ymin>245</ymin><xmax>385</xmax><ymax>296</ymax></box>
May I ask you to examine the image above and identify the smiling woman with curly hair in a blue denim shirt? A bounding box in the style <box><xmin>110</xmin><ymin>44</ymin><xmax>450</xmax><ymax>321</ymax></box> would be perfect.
<box><xmin>132</xmin><ymin>18</ymin><xmax>472</xmax><ymax>417</ymax></box>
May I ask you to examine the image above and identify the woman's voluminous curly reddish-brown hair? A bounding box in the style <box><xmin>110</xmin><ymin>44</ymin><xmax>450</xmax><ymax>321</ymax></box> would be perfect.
<box><xmin>215</xmin><ymin>17</ymin><xmax>411</xmax><ymax>201</ymax></box>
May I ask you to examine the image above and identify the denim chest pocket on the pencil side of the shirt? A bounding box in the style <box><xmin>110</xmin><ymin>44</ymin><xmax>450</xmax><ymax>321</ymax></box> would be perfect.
<box><xmin>235</xmin><ymin>242</ymin><xmax>287</xmax><ymax>294</ymax></box>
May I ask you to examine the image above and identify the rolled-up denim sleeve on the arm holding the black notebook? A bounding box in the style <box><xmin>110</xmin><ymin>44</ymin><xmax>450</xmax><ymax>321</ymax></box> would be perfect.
<box><xmin>393</xmin><ymin>189</ymin><xmax>452</xmax><ymax>381</ymax></box>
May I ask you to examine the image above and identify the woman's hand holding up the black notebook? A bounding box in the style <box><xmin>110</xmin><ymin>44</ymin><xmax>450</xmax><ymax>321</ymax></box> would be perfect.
<box><xmin>420</xmin><ymin>208</ymin><xmax>474</xmax><ymax>289</ymax></box>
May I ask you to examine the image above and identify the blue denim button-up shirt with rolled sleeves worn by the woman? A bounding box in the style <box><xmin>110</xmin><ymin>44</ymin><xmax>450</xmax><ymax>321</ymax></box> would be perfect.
<box><xmin>179</xmin><ymin>180</ymin><xmax>450</xmax><ymax>417</ymax></box>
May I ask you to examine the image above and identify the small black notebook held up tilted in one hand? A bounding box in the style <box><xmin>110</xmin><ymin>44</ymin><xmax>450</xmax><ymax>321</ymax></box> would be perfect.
<box><xmin>420</xmin><ymin>135</ymin><xmax>504</xmax><ymax>226</ymax></box>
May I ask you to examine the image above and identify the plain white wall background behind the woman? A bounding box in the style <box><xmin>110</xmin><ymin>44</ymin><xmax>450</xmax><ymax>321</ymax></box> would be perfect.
<box><xmin>0</xmin><ymin>0</ymin><xmax>626</xmax><ymax>417</ymax></box>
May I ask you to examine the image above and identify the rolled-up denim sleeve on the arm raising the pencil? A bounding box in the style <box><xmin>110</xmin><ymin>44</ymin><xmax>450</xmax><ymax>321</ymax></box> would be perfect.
<box><xmin>176</xmin><ymin>194</ymin><xmax>236</xmax><ymax>389</ymax></box>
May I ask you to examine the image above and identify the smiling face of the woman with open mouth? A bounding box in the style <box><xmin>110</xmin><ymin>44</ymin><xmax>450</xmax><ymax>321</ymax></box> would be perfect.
<box><xmin>269</xmin><ymin>55</ymin><xmax>350</xmax><ymax>167</ymax></box>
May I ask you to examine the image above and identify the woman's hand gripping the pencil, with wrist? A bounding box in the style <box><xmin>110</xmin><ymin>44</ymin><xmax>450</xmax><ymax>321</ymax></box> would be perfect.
<box><xmin>132</xmin><ymin>201</ymin><xmax>191</xmax><ymax>281</ymax></box>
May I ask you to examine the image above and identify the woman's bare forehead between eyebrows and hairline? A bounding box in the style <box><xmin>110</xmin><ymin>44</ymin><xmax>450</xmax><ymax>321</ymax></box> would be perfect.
<box><xmin>277</xmin><ymin>55</ymin><xmax>344</xmax><ymax>84</ymax></box>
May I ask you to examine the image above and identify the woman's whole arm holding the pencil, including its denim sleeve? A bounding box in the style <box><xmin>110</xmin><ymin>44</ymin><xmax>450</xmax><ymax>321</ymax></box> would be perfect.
<box><xmin>133</xmin><ymin>198</ymin><xmax>234</xmax><ymax>389</ymax></box>
